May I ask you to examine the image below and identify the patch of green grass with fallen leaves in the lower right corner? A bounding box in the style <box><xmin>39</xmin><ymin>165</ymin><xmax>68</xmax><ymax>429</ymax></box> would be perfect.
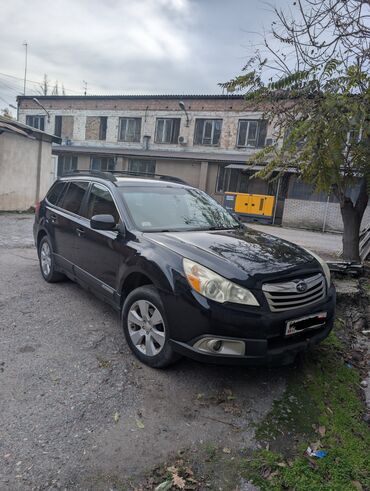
<box><xmin>240</xmin><ymin>333</ymin><xmax>370</xmax><ymax>491</ymax></box>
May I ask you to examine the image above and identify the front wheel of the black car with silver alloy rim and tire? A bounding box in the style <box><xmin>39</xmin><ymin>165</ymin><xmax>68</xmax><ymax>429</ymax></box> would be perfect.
<box><xmin>122</xmin><ymin>285</ymin><xmax>180</xmax><ymax>368</ymax></box>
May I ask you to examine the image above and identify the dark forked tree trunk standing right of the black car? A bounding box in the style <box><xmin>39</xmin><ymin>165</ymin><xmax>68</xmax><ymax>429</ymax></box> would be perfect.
<box><xmin>340</xmin><ymin>179</ymin><xmax>369</xmax><ymax>262</ymax></box>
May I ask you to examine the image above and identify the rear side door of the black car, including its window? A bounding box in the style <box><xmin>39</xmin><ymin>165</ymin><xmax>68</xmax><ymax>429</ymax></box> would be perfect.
<box><xmin>46</xmin><ymin>181</ymin><xmax>89</xmax><ymax>274</ymax></box>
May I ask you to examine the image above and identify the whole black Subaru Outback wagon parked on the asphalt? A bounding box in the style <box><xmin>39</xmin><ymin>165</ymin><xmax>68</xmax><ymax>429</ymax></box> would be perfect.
<box><xmin>34</xmin><ymin>172</ymin><xmax>335</xmax><ymax>367</ymax></box>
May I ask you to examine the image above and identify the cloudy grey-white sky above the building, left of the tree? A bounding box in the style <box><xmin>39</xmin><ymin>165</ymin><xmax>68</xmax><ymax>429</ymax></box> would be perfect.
<box><xmin>0</xmin><ymin>0</ymin><xmax>291</xmax><ymax>108</ymax></box>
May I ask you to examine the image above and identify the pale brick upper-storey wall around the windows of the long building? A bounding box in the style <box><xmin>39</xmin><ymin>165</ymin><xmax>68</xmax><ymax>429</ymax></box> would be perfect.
<box><xmin>19</xmin><ymin>97</ymin><xmax>273</xmax><ymax>154</ymax></box>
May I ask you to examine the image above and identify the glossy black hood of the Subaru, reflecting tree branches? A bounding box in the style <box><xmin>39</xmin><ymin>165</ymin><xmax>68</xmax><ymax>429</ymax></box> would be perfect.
<box><xmin>144</xmin><ymin>227</ymin><xmax>321</xmax><ymax>287</ymax></box>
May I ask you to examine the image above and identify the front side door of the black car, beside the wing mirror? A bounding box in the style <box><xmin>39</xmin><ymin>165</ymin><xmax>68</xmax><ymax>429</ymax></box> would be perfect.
<box><xmin>76</xmin><ymin>183</ymin><xmax>126</xmax><ymax>302</ymax></box>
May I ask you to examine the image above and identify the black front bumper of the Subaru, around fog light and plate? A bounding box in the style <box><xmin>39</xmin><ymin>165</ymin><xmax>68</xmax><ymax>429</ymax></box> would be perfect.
<box><xmin>164</xmin><ymin>286</ymin><xmax>335</xmax><ymax>366</ymax></box>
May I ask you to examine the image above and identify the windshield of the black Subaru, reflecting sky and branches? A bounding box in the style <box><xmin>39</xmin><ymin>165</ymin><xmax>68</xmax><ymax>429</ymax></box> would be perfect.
<box><xmin>119</xmin><ymin>186</ymin><xmax>240</xmax><ymax>232</ymax></box>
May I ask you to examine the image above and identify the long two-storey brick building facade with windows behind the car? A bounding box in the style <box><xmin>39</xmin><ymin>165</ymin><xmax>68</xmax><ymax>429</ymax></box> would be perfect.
<box><xmin>18</xmin><ymin>95</ymin><xmax>370</xmax><ymax>231</ymax></box>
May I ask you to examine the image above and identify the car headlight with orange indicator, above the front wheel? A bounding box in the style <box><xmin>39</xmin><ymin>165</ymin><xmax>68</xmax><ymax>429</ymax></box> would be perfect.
<box><xmin>183</xmin><ymin>258</ymin><xmax>259</xmax><ymax>306</ymax></box>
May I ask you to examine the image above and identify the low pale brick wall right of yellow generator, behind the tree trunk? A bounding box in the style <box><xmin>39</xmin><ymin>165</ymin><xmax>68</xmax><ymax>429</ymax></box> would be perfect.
<box><xmin>283</xmin><ymin>199</ymin><xmax>370</xmax><ymax>232</ymax></box>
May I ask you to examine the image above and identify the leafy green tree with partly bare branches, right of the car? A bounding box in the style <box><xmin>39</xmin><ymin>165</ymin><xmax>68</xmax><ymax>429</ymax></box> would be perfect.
<box><xmin>220</xmin><ymin>0</ymin><xmax>370</xmax><ymax>261</ymax></box>
